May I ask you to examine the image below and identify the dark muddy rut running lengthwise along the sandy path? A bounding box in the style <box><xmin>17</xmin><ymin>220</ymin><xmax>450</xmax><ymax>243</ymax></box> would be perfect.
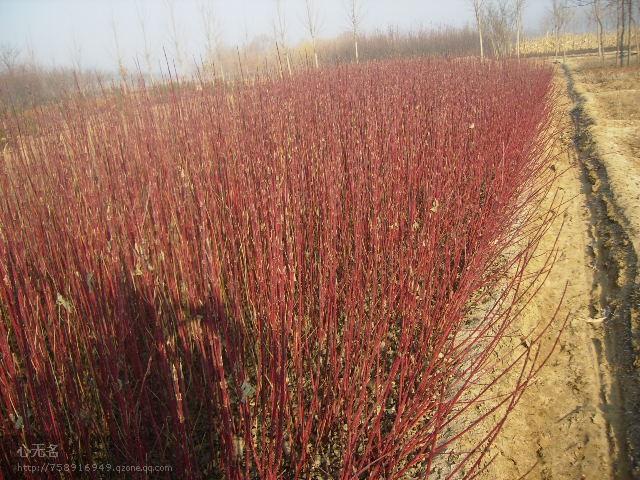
<box><xmin>563</xmin><ymin>65</ymin><xmax>640</xmax><ymax>479</ymax></box>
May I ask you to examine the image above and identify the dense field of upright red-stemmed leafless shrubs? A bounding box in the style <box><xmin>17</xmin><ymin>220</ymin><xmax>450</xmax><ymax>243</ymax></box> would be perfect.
<box><xmin>0</xmin><ymin>60</ymin><xmax>552</xmax><ymax>479</ymax></box>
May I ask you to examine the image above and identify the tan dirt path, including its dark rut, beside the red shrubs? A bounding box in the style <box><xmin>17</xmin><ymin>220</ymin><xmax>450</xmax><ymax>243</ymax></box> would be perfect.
<box><xmin>482</xmin><ymin>60</ymin><xmax>640</xmax><ymax>480</ymax></box>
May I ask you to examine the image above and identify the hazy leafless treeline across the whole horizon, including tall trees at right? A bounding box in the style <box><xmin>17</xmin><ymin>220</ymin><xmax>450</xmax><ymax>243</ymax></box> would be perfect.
<box><xmin>0</xmin><ymin>0</ymin><xmax>640</xmax><ymax>108</ymax></box>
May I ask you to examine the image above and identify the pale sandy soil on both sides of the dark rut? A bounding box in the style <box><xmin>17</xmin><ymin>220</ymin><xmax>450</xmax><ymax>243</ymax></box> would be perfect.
<box><xmin>472</xmin><ymin>58</ymin><xmax>640</xmax><ymax>480</ymax></box>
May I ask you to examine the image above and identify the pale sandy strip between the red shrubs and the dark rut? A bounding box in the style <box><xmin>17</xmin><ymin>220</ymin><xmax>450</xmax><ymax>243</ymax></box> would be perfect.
<box><xmin>481</xmin><ymin>79</ymin><xmax>611</xmax><ymax>479</ymax></box>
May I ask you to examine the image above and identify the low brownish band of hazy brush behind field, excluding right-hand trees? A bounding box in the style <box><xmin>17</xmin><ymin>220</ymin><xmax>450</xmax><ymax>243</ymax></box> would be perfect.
<box><xmin>0</xmin><ymin>27</ymin><xmax>478</xmax><ymax>108</ymax></box>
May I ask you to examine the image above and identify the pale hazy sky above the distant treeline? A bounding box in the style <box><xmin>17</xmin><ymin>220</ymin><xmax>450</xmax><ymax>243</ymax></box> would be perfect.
<box><xmin>0</xmin><ymin>0</ymin><xmax>549</xmax><ymax>70</ymax></box>
